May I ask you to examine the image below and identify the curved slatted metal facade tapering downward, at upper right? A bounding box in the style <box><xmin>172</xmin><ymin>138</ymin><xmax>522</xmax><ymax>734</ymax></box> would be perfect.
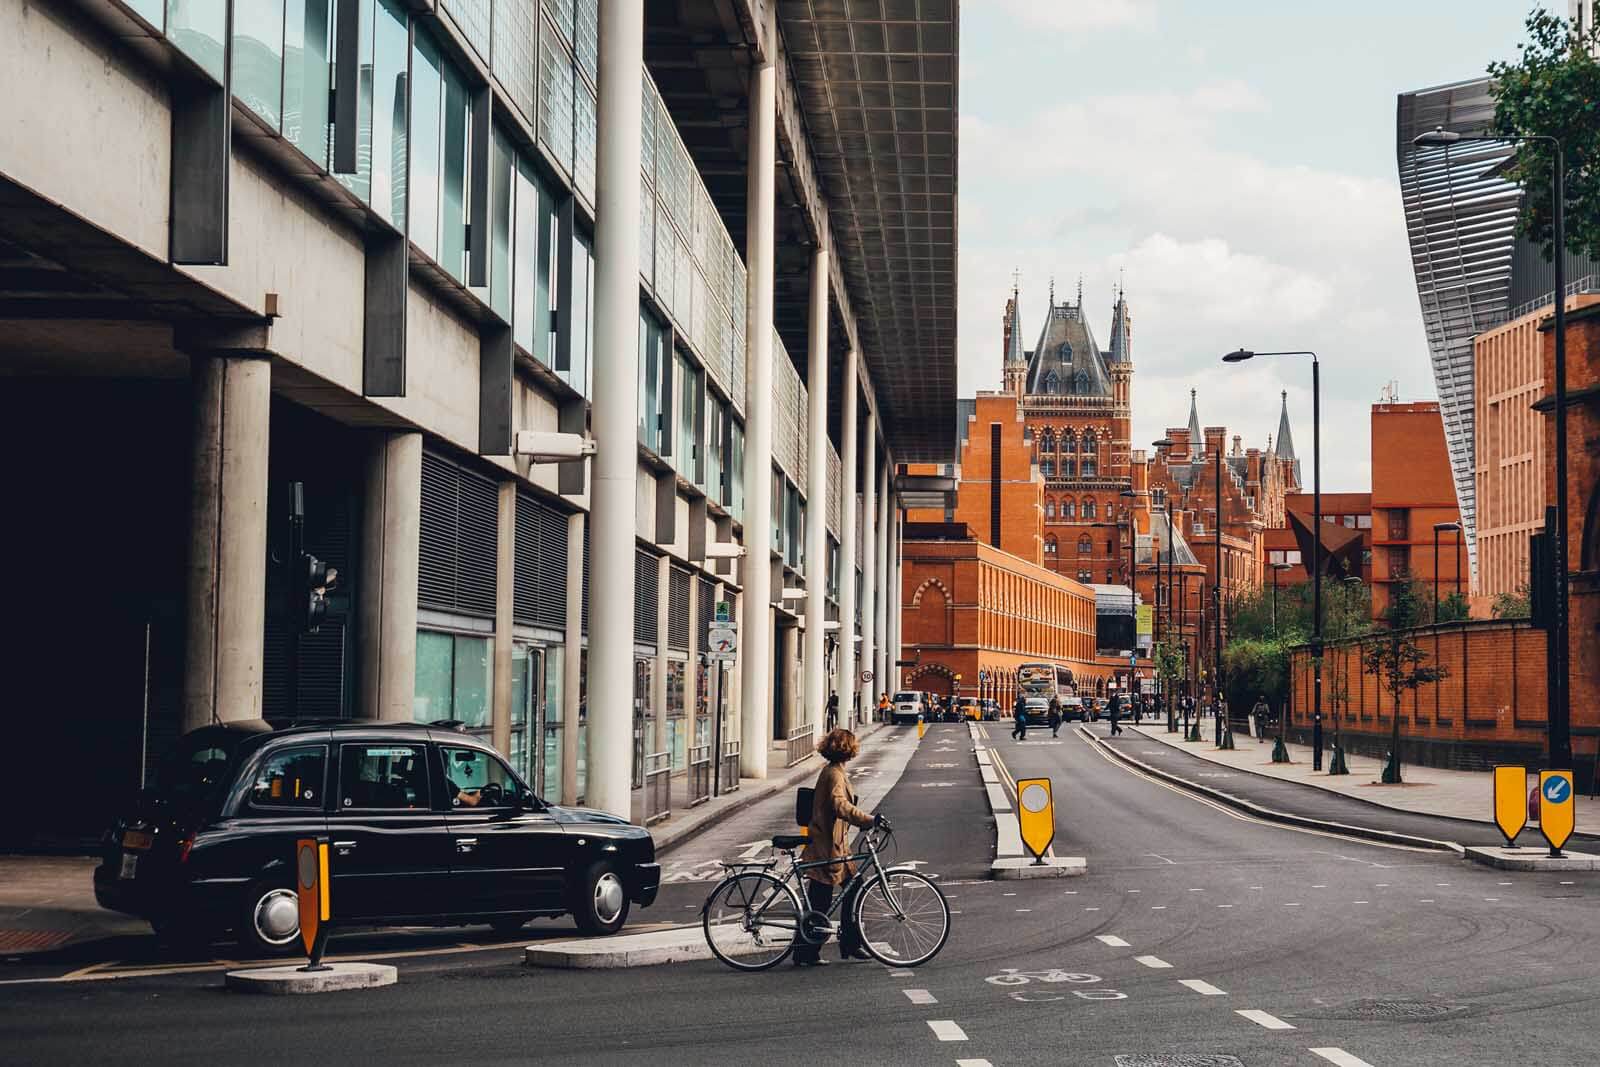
<box><xmin>1395</xmin><ymin>78</ymin><xmax>1522</xmax><ymax>585</ymax></box>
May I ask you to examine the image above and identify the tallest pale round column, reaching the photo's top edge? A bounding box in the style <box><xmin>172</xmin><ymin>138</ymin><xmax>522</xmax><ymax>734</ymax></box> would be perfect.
<box><xmin>586</xmin><ymin>0</ymin><xmax>645</xmax><ymax>819</ymax></box>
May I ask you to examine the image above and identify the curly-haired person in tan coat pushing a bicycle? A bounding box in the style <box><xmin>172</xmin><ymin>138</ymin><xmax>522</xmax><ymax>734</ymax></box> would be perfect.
<box><xmin>794</xmin><ymin>729</ymin><xmax>880</xmax><ymax>966</ymax></box>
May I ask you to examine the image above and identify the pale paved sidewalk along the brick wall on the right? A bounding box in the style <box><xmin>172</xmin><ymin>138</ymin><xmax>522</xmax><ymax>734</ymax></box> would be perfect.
<box><xmin>1125</xmin><ymin>720</ymin><xmax>1600</xmax><ymax>833</ymax></box>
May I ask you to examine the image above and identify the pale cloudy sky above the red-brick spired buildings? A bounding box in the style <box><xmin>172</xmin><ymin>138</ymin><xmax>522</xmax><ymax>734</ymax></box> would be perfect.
<box><xmin>958</xmin><ymin>0</ymin><xmax>1542</xmax><ymax>491</ymax></box>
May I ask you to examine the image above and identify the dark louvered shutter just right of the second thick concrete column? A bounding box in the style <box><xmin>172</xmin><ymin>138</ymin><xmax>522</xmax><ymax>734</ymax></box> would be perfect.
<box><xmin>418</xmin><ymin>451</ymin><xmax>499</xmax><ymax>619</ymax></box>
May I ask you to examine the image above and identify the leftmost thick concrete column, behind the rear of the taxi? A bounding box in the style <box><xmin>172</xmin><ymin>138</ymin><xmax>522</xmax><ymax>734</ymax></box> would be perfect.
<box><xmin>182</xmin><ymin>354</ymin><xmax>272</xmax><ymax>729</ymax></box>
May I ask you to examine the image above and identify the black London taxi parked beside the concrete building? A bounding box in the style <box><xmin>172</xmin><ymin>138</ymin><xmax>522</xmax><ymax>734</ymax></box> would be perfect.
<box><xmin>94</xmin><ymin>720</ymin><xmax>661</xmax><ymax>953</ymax></box>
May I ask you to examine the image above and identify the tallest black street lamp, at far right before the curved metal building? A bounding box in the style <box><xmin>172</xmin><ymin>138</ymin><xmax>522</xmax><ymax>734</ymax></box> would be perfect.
<box><xmin>1411</xmin><ymin>126</ymin><xmax>1573</xmax><ymax>768</ymax></box>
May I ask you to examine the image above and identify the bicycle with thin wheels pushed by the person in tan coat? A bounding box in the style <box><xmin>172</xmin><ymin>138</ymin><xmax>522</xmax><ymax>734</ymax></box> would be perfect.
<box><xmin>701</xmin><ymin>819</ymin><xmax>950</xmax><ymax>971</ymax></box>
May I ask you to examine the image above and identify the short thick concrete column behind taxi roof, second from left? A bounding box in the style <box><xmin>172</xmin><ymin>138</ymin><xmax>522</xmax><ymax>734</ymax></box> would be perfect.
<box><xmin>355</xmin><ymin>434</ymin><xmax>422</xmax><ymax>721</ymax></box>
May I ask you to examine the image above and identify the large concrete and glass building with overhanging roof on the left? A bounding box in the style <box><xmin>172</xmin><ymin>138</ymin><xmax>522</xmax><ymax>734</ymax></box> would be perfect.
<box><xmin>0</xmin><ymin>0</ymin><xmax>958</xmax><ymax>843</ymax></box>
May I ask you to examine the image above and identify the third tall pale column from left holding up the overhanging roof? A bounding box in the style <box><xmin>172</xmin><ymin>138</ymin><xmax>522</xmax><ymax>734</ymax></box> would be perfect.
<box><xmin>805</xmin><ymin>248</ymin><xmax>829</xmax><ymax>735</ymax></box>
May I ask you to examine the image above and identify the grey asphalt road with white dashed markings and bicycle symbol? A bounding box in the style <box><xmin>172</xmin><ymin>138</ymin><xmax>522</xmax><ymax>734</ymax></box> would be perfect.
<box><xmin>0</xmin><ymin>725</ymin><xmax>1600</xmax><ymax>1067</ymax></box>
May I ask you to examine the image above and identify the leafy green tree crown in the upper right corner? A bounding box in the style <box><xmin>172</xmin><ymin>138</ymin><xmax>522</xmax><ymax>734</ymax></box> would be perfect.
<box><xmin>1488</xmin><ymin>8</ymin><xmax>1600</xmax><ymax>259</ymax></box>
